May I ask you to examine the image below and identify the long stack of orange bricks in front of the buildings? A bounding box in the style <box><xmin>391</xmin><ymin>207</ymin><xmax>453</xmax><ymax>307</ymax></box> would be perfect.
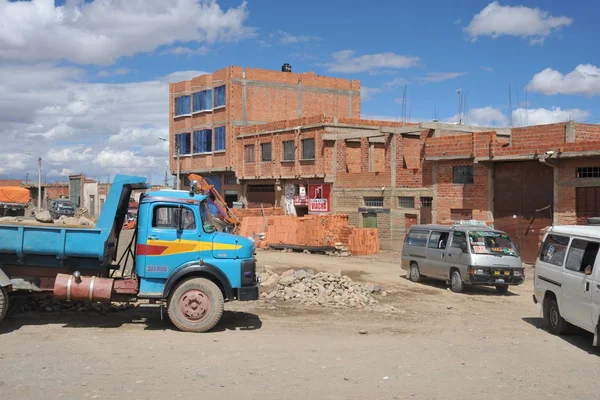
<box><xmin>239</xmin><ymin>215</ymin><xmax>379</xmax><ymax>255</ymax></box>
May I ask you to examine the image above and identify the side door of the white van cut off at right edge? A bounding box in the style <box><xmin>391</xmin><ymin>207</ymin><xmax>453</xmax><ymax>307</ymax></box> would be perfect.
<box><xmin>562</xmin><ymin>239</ymin><xmax>600</xmax><ymax>331</ymax></box>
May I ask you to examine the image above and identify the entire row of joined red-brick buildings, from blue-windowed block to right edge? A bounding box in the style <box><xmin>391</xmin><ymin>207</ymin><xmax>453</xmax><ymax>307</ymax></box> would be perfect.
<box><xmin>166</xmin><ymin>67</ymin><xmax>600</xmax><ymax>261</ymax></box>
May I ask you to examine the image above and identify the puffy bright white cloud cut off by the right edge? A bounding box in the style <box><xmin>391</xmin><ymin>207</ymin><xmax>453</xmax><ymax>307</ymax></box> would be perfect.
<box><xmin>528</xmin><ymin>64</ymin><xmax>600</xmax><ymax>96</ymax></box>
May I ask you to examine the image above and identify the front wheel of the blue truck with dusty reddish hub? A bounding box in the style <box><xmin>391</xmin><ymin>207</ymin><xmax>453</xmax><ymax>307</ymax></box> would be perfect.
<box><xmin>167</xmin><ymin>278</ymin><xmax>225</xmax><ymax>332</ymax></box>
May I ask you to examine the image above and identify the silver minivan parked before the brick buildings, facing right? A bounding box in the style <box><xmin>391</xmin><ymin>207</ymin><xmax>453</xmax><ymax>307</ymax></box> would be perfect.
<box><xmin>402</xmin><ymin>225</ymin><xmax>525</xmax><ymax>294</ymax></box>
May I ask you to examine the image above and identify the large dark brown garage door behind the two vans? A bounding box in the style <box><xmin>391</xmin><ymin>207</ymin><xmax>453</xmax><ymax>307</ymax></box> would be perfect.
<box><xmin>494</xmin><ymin>161</ymin><xmax>554</xmax><ymax>263</ymax></box>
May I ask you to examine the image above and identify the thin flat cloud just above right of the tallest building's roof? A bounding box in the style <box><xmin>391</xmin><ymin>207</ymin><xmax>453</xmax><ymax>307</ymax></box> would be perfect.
<box><xmin>326</xmin><ymin>50</ymin><xmax>419</xmax><ymax>73</ymax></box>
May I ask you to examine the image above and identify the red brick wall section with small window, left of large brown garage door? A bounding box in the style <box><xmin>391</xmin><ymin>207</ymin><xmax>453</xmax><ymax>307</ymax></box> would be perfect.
<box><xmin>435</xmin><ymin>160</ymin><xmax>488</xmax><ymax>223</ymax></box>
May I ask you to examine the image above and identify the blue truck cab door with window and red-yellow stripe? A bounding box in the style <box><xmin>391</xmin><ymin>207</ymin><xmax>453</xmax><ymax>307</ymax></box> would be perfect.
<box><xmin>137</xmin><ymin>203</ymin><xmax>200</xmax><ymax>279</ymax></box>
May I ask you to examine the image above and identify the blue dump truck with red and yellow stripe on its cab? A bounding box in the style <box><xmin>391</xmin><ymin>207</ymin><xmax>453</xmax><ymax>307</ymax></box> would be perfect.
<box><xmin>0</xmin><ymin>175</ymin><xmax>259</xmax><ymax>332</ymax></box>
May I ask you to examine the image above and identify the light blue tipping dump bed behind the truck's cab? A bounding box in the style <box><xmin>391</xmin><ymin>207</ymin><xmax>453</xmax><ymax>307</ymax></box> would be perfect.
<box><xmin>0</xmin><ymin>175</ymin><xmax>148</xmax><ymax>268</ymax></box>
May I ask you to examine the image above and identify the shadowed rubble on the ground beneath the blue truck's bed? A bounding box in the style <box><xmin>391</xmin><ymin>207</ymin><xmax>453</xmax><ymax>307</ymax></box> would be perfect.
<box><xmin>11</xmin><ymin>296</ymin><xmax>135</xmax><ymax>315</ymax></box>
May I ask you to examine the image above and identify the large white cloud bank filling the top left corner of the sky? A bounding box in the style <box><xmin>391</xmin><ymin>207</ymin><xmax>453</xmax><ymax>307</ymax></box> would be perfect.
<box><xmin>0</xmin><ymin>0</ymin><xmax>255</xmax><ymax>65</ymax></box>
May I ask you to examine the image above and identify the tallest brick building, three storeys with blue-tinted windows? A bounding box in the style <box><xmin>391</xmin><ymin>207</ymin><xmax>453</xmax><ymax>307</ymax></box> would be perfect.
<box><xmin>169</xmin><ymin>67</ymin><xmax>360</xmax><ymax>203</ymax></box>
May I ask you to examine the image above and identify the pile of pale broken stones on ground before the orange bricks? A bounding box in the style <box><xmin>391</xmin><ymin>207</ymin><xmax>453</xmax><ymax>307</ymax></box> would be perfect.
<box><xmin>260</xmin><ymin>267</ymin><xmax>397</xmax><ymax>312</ymax></box>
